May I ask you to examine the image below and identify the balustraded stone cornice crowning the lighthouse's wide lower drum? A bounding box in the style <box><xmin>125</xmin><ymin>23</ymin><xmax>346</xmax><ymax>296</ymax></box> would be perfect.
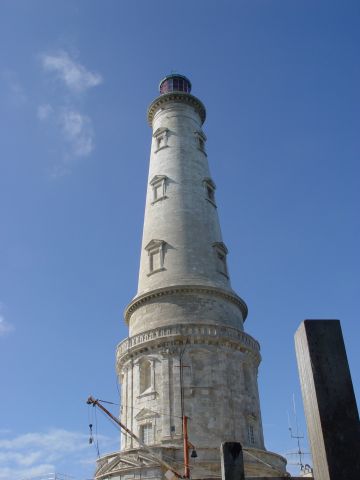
<box><xmin>116</xmin><ymin>323</ymin><xmax>261</xmax><ymax>366</ymax></box>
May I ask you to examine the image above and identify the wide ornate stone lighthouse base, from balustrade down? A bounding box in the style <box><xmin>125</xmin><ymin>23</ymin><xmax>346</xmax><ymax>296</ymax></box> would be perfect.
<box><xmin>109</xmin><ymin>323</ymin><xmax>286</xmax><ymax>480</ymax></box>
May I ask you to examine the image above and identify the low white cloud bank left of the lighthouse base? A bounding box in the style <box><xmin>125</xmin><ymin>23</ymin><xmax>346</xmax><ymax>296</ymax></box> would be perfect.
<box><xmin>0</xmin><ymin>429</ymin><xmax>113</xmax><ymax>480</ymax></box>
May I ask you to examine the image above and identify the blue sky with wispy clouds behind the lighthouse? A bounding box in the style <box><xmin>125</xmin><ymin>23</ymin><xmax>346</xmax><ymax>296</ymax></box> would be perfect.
<box><xmin>0</xmin><ymin>0</ymin><xmax>360</xmax><ymax>480</ymax></box>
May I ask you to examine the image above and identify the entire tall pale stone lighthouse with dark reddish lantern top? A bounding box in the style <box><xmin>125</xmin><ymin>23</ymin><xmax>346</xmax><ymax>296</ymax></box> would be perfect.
<box><xmin>96</xmin><ymin>74</ymin><xmax>285</xmax><ymax>479</ymax></box>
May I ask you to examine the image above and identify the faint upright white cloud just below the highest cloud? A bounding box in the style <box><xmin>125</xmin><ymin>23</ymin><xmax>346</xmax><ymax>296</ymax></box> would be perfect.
<box><xmin>59</xmin><ymin>108</ymin><xmax>94</xmax><ymax>157</ymax></box>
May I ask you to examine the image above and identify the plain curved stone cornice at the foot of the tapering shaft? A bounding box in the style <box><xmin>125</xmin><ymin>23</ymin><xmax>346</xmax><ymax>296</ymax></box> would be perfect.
<box><xmin>124</xmin><ymin>285</ymin><xmax>248</xmax><ymax>324</ymax></box>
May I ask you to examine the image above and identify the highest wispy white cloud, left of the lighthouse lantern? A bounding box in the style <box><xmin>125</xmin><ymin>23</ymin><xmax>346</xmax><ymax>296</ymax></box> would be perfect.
<box><xmin>41</xmin><ymin>50</ymin><xmax>102</xmax><ymax>93</ymax></box>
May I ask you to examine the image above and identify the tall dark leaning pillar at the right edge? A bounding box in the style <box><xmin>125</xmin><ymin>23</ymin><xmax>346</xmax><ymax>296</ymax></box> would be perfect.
<box><xmin>295</xmin><ymin>320</ymin><xmax>360</xmax><ymax>480</ymax></box>
